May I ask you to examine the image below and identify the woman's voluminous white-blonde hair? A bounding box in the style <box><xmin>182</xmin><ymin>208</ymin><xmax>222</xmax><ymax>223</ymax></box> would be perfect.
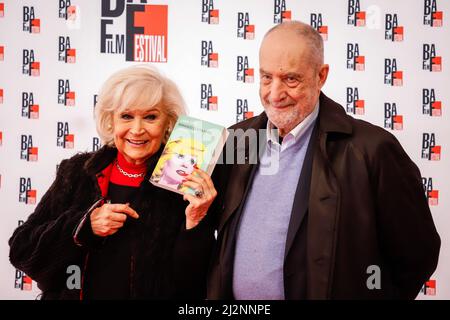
<box><xmin>95</xmin><ymin>65</ymin><xmax>186</xmax><ymax>146</ymax></box>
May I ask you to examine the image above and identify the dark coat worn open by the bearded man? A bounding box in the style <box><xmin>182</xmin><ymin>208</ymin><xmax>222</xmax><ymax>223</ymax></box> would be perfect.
<box><xmin>208</xmin><ymin>94</ymin><xmax>440</xmax><ymax>299</ymax></box>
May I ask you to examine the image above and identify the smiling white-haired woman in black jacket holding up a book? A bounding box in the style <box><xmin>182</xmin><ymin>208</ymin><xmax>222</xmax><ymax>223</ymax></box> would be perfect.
<box><xmin>9</xmin><ymin>66</ymin><xmax>216</xmax><ymax>299</ymax></box>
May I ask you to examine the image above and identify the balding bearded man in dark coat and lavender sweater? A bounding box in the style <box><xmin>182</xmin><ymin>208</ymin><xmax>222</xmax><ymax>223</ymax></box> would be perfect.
<box><xmin>208</xmin><ymin>21</ymin><xmax>440</xmax><ymax>299</ymax></box>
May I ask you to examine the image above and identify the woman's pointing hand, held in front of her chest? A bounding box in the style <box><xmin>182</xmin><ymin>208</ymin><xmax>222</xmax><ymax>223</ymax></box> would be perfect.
<box><xmin>90</xmin><ymin>203</ymin><xmax>139</xmax><ymax>237</ymax></box>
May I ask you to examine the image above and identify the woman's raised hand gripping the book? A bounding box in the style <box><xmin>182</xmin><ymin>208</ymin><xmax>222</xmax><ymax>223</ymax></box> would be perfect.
<box><xmin>183</xmin><ymin>168</ymin><xmax>217</xmax><ymax>229</ymax></box>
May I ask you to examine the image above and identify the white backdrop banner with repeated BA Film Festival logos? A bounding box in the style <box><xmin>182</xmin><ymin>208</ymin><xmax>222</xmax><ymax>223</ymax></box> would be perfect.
<box><xmin>0</xmin><ymin>0</ymin><xmax>450</xmax><ymax>299</ymax></box>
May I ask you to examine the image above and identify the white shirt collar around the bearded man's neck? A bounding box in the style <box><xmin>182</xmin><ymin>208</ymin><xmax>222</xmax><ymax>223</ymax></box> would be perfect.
<box><xmin>266</xmin><ymin>101</ymin><xmax>319</xmax><ymax>152</ymax></box>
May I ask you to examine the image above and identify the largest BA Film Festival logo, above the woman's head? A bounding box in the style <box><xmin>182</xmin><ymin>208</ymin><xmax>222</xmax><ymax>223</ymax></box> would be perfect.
<box><xmin>100</xmin><ymin>0</ymin><xmax>168</xmax><ymax>63</ymax></box>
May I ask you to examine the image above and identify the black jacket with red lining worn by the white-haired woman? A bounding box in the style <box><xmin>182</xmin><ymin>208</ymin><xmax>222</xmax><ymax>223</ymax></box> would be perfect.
<box><xmin>9</xmin><ymin>147</ymin><xmax>214</xmax><ymax>299</ymax></box>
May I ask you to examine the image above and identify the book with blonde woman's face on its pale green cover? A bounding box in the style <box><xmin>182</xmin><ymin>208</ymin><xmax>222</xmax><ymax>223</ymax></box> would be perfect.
<box><xmin>150</xmin><ymin>115</ymin><xmax>229</xmax><ymax>195</ymax></box>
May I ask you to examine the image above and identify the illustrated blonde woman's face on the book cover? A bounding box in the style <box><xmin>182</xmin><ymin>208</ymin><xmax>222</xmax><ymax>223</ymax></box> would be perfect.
<box><xmin>153</xmin><ymin>138</ymin><xmax>205</xmax><ymax>191</ymax></box>
